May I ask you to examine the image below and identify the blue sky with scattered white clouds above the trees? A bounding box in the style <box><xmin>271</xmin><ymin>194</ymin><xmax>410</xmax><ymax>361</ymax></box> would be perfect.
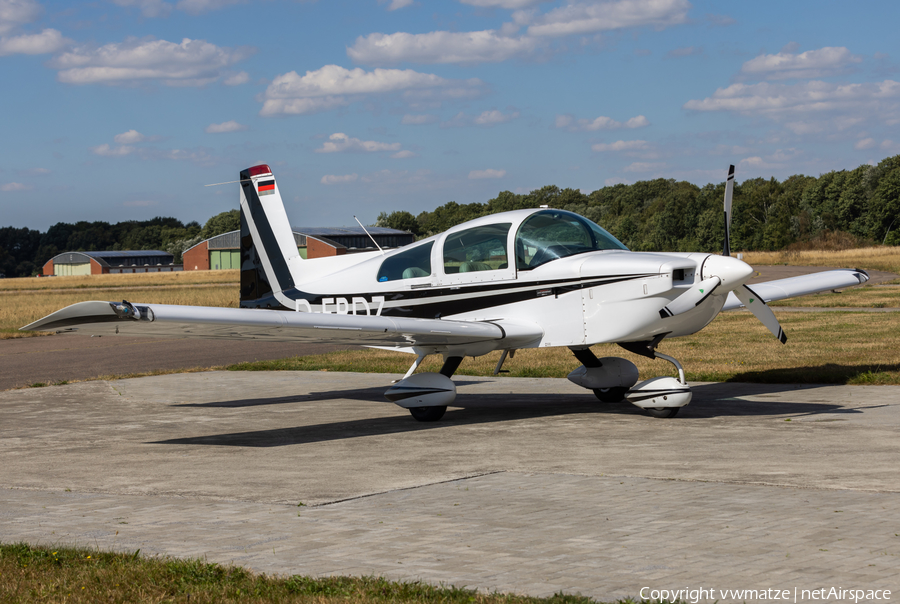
<box><xmin>0</xmin><ymin>0</ymin><xmax>900</xmax><ymax>230</ymax></box>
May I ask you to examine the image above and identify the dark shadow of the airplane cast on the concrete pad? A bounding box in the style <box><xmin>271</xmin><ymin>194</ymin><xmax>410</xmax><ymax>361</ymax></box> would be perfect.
<box><xmin>148</xmin><ymin>383</ymin><xmax>861</xmax><ymax>447</ymax></box>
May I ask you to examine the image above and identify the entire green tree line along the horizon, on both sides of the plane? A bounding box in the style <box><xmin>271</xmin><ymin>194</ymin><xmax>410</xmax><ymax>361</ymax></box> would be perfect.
<box><xmin>7</xmin><ymin>155</ymin><xmax>900</xmax><ymax>277</ymax></box>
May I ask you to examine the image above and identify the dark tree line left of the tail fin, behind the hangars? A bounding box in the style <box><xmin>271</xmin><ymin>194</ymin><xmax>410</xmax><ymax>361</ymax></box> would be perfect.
<box><xmin>0</xmin><ymin>210</ymin><xmax>241</xmax><ymax>277</ymax></box>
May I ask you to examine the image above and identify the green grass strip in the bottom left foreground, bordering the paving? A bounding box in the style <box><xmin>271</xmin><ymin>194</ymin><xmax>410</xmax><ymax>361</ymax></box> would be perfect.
<box><xmin>0</xmin><ymin>543</ymin><xmax>648</xmax><ymax>604</ymax></box>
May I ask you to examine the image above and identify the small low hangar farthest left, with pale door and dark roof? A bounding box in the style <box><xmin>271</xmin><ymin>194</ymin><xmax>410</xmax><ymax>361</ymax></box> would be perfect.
<box><xmin>41</xmin><ymin>250</ymin><xmax>181</xmax><ymax>276</ymax></box>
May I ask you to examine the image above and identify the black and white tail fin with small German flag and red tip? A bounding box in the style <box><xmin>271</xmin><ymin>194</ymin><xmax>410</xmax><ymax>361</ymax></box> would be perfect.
<box><xmin>240</xmin><ymin>164</ymin><xmax>303</xmax><ymax>308</ymax></box>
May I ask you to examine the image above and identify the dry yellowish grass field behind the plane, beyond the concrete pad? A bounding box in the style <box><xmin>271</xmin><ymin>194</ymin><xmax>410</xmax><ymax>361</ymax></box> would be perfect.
<box><xmin>7</xmin><ymin>248</ymin><xmax>900</xmax><ymax>384</ymax></box>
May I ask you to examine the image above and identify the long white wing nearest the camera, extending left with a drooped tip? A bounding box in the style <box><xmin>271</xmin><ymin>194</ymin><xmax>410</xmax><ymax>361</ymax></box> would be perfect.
<box><xmin>21</xmin><ymin>301</ymin><xmax>543</xmax><ymax>349</ymax></box>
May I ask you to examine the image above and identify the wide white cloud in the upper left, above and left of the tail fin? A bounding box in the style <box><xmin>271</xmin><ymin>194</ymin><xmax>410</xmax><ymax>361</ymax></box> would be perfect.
<box><xmin>50</xmin><ymin>38</ymin><xmax>253</xmax><ymax>86</ymax></box>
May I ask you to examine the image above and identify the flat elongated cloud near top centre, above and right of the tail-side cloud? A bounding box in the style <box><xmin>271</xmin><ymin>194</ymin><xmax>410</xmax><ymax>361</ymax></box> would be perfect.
<box><xmin>347</xmin><ymin>29</ymin><xmax>538</xmax><ymax>65</ymax></box>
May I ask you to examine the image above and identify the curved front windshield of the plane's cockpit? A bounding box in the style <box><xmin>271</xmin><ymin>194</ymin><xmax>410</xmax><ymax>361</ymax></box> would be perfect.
<box><xmin>516</xmin><ymin>210</ymin><xmax>628</xmax><ymax>271</ymax></box>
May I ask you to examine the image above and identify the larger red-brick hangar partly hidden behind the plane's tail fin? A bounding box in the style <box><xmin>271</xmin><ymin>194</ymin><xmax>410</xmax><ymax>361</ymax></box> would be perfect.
<box><xmin>182</xmin><ymin>227</ymin><xmax>415</xmax><ymax>271</ymax></box>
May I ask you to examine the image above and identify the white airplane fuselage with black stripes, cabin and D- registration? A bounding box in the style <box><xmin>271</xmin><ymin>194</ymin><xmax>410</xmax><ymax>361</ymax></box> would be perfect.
<box><xmin>243</xmin><ymin>209</ymin><xmax>750</xmax><ymax>347</ymax></box>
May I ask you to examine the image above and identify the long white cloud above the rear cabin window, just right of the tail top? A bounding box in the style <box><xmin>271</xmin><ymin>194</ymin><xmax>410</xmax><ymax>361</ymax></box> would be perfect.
<box><xmin>259</xmin><ymin>65</ymin><xmax>484</xmax><ymax>116</ymax></box>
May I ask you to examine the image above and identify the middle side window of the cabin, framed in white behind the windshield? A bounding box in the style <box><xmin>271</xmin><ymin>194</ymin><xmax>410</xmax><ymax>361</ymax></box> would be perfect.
<box><xmin>444</xmin><ymin>222</ymin><xmax>512</xmax><ymax>275</ymax></box>
